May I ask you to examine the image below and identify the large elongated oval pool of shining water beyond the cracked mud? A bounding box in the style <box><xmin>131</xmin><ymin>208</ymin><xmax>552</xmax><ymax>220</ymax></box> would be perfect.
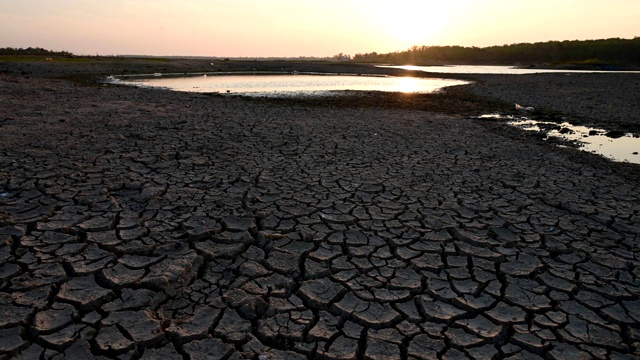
<box><xmin>115</xmin><ymin>74</ymin><xmax>469</xmax><ymax>96</ymax></box>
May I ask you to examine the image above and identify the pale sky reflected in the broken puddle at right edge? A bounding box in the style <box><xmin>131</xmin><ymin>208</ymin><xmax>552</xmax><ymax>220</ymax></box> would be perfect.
<box><xmin>504</xmin><ymin>116</ymin><xmax>640</xmax><ymax>164</ymax></box>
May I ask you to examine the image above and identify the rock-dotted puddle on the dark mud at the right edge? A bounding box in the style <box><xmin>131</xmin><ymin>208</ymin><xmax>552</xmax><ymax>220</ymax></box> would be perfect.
<box><xmin>479</xmin><ymin>114</ymin><xmax>640</xmax><ymax>164</ymax></box>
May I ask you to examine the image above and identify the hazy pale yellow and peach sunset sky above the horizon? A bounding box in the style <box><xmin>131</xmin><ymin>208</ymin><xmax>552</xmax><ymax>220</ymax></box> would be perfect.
<box><xmin>0</xmin><ymin>0</ymin><xmax>640</xmax><ymax>57</ymax></box>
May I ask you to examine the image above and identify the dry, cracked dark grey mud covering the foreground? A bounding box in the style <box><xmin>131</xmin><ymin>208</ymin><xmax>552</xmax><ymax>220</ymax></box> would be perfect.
<box><xmin>0</xmin><ymin>60</ymin><xmax>640</xmax><ymax>360</ymax></box>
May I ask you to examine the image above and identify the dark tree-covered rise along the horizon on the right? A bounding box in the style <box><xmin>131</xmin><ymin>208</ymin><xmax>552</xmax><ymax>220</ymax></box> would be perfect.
<box><xmin>352</xmin><ymin>37</ymin><xmax>640</xmax><ymax>65</ymax></box>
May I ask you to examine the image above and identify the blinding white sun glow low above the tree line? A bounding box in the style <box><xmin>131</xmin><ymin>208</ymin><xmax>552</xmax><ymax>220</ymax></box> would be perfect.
<box><xmin>379</xmin><ymin>1</ymin><xmax>448</xmax><ymax>50</ymax></box>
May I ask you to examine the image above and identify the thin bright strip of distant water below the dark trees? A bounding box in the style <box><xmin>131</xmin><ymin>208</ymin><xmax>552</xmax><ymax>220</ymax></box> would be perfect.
<box><xmin>380</xmin><ymin>65</ymin><xmax>640</xmax><ymax>75</ymax></box>
